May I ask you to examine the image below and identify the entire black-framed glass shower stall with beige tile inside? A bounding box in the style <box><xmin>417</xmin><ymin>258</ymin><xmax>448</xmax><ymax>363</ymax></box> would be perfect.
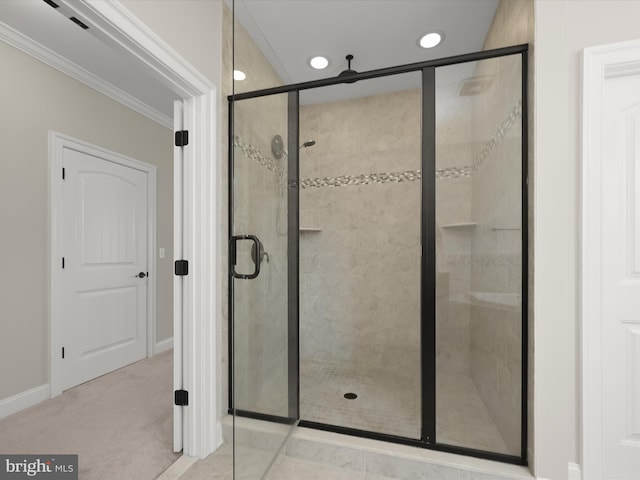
<box><xmin>229</xmin><ymin>46</ymin><xmax>527</xmax><ymax>478</ymax></box>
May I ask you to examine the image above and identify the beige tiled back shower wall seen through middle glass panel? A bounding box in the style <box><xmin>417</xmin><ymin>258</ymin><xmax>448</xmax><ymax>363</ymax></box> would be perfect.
<box><xmin>300</xmin><ymin>86</ymin><xmax>420</xmax><ymax>380</ymax></box>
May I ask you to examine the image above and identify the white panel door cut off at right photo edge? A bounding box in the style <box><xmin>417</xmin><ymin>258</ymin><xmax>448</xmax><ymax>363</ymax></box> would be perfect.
<box><xmin>601</xmin><ymin>66</ymin><xmax>640</xmax><ymax>479</ymax></box>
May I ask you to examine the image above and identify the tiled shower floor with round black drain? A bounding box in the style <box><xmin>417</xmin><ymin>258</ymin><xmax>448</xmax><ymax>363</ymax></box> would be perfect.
<box><xmin>300</xmin><ymin>360</ymin><xmax>507</xmax><ymax>453</ymax></box>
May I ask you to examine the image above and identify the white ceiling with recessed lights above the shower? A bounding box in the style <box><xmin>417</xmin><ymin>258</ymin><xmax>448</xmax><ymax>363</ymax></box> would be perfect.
<box><xmin>227</xmin><ymin>0</ymin><xmax>499</xmax><ymax>103</ymax></box>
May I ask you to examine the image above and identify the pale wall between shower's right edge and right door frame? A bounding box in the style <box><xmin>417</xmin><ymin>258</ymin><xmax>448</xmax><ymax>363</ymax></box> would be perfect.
<box><xmin>533</xmin><ymin>0</ymin><xmax>640</xmax><ymax>478</ymax></box>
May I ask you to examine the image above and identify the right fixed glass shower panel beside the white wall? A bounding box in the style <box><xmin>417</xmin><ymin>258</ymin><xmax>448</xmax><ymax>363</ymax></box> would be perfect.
<box><xmin>436</xmin><ymin>55</ymin><xmax>523</xmax><ymax>456</ymax></box>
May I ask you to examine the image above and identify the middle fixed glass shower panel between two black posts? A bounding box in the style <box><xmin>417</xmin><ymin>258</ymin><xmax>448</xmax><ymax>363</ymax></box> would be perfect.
<box><xmin>299</xmin><ymin>72</ymin><xmax>421</xmax><ymax>439</ymax></box>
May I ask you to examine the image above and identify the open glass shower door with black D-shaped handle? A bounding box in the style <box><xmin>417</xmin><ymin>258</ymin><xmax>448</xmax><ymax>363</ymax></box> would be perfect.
<box><xmin>229</xmin><ymin>94</ymin><xmax>298</xmax><ymax>479</ymax></box>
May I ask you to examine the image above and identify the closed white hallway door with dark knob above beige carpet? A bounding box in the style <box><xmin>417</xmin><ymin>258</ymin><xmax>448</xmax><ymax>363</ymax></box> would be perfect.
<box><xmin>60</xmin><ymin>148</ymin><xmax>148</xmax><ymax>390</ymax></box>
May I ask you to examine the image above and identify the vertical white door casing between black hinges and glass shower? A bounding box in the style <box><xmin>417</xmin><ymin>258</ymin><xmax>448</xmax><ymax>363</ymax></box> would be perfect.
<box><xmin>183</xmin><ymin>90</ymin><xmax>222</xmax><ymax>456</ymax></box>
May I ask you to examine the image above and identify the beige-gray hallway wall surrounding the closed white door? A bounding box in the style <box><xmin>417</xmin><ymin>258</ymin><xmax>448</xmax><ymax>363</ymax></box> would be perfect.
<box><xmin>0</xmin><ymin>42</ymin><xmax>173</xmax><ymax>399</ymax></box>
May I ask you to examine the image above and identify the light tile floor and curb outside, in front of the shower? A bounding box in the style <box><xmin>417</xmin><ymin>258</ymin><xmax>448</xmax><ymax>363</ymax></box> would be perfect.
<box><xmin>169</xmin><ymin>436</ymin><xmax>534</xmax><ymax>480</ymax></box>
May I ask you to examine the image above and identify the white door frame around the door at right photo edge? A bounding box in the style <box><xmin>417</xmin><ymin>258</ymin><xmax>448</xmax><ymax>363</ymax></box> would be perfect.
<box><xmin>580</xmin><ymin>40</ymin><xmax>640</xmax><ymax>478</ymax></box>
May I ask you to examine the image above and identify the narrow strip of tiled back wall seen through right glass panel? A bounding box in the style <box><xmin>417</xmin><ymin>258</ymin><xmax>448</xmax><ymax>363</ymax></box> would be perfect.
<box><xmin>435</xmin><ymin>84</ymin><xmax>474</xmax><ymax>376</ymax></box>
